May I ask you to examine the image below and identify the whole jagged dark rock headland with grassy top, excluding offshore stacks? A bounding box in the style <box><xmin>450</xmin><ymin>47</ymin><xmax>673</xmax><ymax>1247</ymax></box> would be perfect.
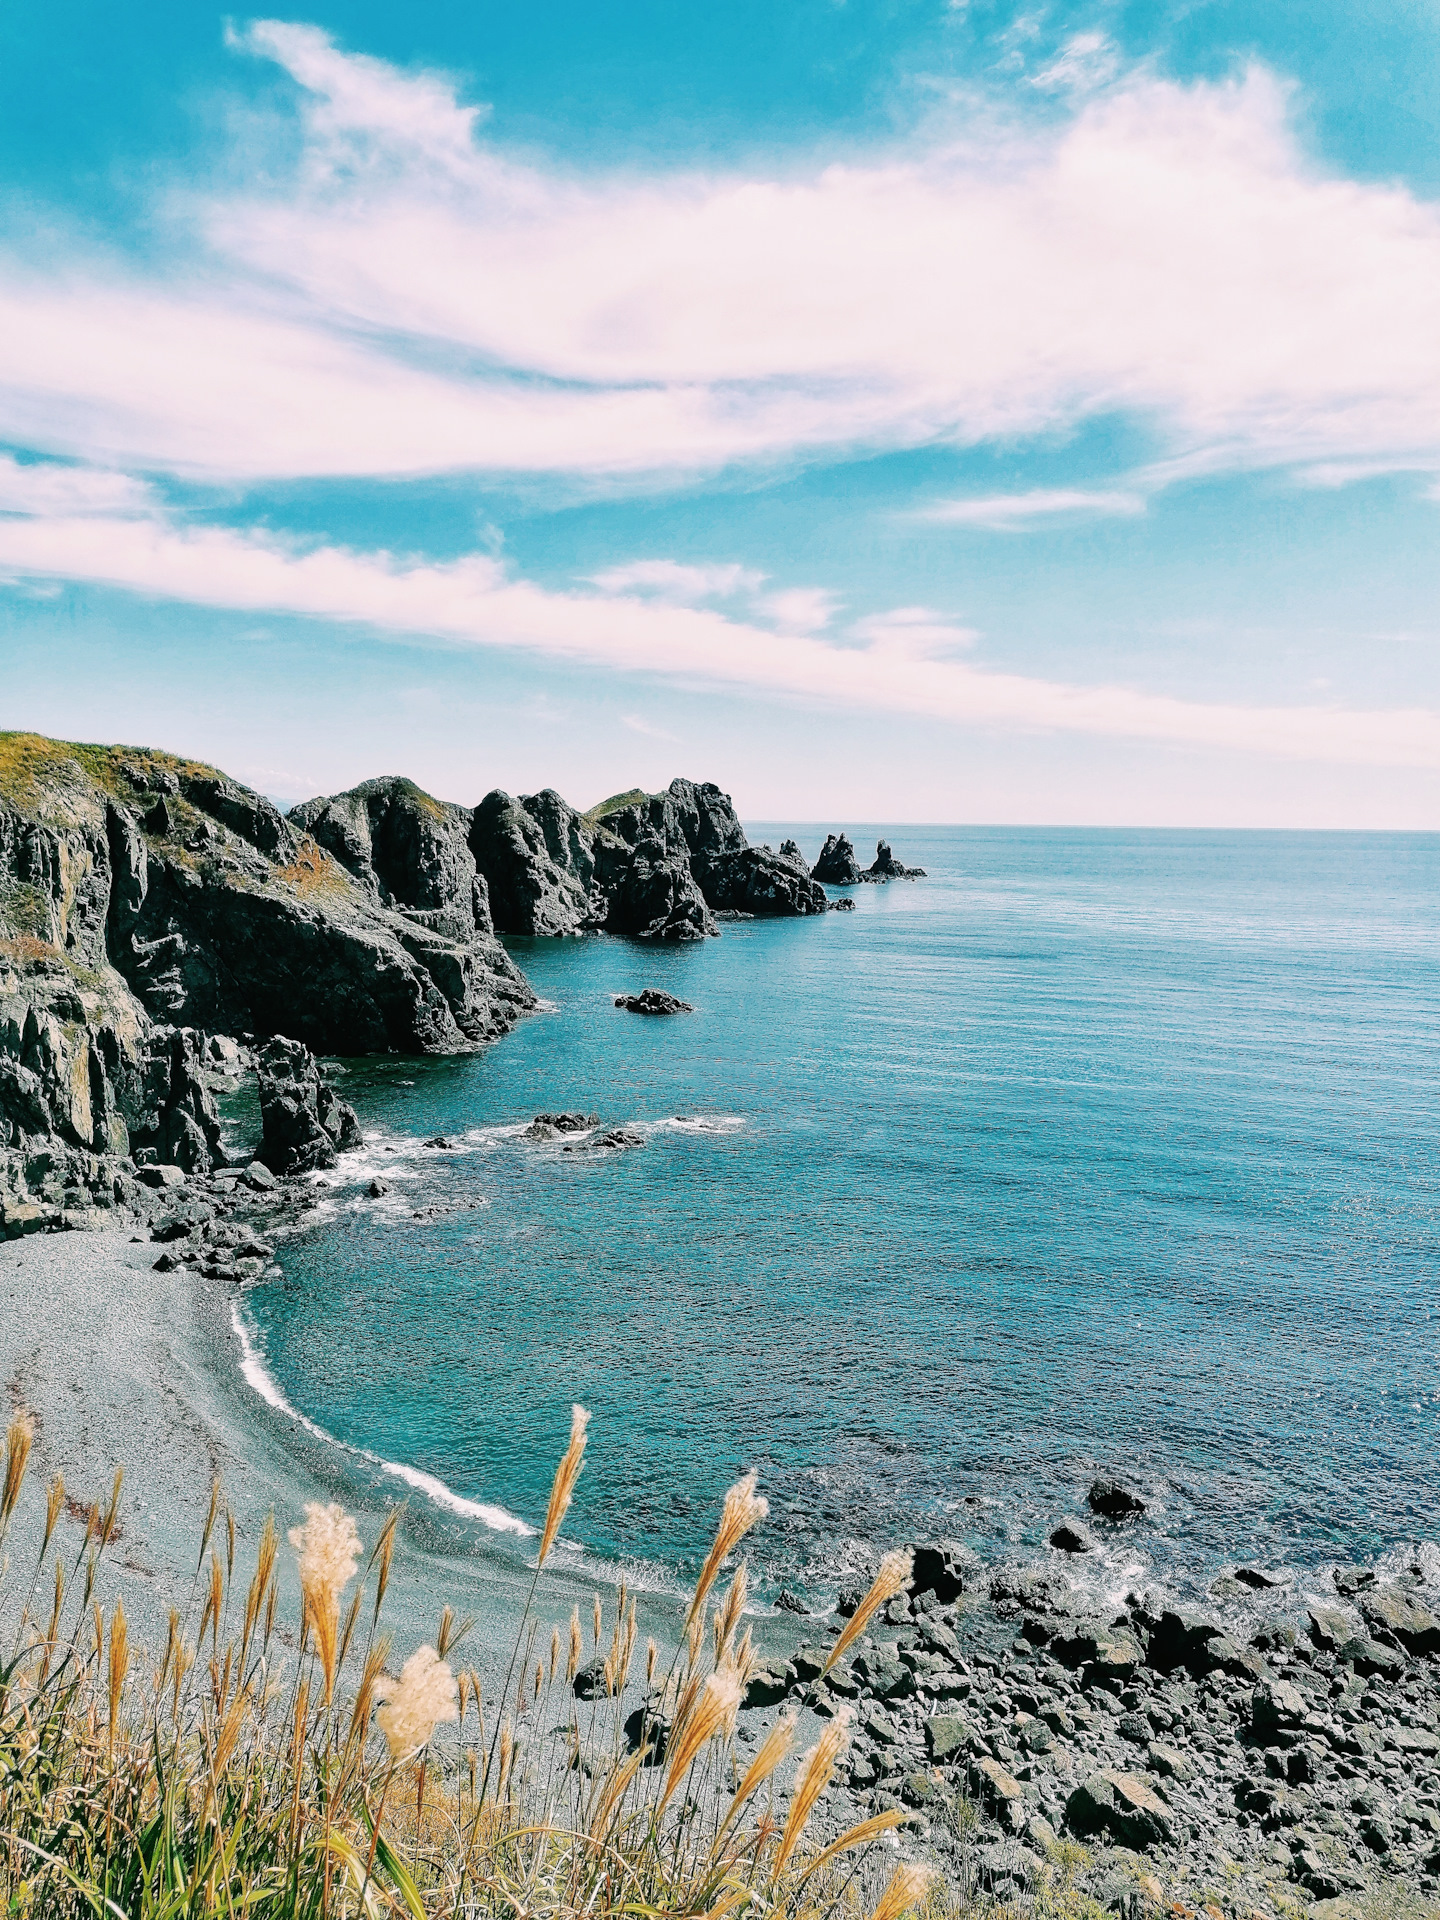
<box><xmin>0</xmin><ymin>733</ymin><xmax>844</xmax><ymax>1233</ymax></box>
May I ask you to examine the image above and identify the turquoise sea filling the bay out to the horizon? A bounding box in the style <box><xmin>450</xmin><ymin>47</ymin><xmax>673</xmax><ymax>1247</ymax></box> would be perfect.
<box><xmin>248</xmin><ymin>826</ymin><xmax>1440</xmax><ymax>1597</ymax></box>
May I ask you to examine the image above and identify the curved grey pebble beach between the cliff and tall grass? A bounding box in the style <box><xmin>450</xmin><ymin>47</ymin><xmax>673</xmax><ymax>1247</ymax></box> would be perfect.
<box><xmin>0</xmin><ymin>1231</ymin><xmax>706</xmax><ymax>1676</ymax></box>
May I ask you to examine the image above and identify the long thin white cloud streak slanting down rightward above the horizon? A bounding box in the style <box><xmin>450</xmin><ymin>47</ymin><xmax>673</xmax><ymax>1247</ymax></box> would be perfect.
<box><xmin>0</xmin><ymin>516</ymin><xmax>1440</xmax><ymax>768</ymax></box>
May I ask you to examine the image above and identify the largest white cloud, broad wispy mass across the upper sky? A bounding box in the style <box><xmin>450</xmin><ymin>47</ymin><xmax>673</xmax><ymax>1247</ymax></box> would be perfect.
<box><xmin>0</xmin><ymin>33</ymin><xmax>1440</xmax><ymax>478</ymax></box>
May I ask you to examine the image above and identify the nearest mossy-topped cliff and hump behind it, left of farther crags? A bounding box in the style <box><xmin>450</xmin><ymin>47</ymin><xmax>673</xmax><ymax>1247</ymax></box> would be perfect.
<box><xmin>0</xmin><ymin>733</ymin><xmax>534</xmax><ymax>1229</ymax></box>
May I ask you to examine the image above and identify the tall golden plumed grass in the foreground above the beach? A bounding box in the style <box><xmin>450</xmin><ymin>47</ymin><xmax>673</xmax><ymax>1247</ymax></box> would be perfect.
<box><xmin>0</xmin><ymin>1407</ymin><xmax>963</xmax><ymax>1920</ymax></box>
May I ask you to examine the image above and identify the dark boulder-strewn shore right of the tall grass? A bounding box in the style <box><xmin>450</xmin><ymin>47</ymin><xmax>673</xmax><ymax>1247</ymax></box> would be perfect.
<box><xmin>714</xmin><ymin>1520</ymin><xmax>1440</xmax><ymax>1920</ymax></box>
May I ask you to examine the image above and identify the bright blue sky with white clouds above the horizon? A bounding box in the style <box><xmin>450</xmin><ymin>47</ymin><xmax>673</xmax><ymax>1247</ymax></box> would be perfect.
<box><xmin>0</xmin><ymin>0</ymin><xmax>1440</xmax><ymax>829</ymax></box>
